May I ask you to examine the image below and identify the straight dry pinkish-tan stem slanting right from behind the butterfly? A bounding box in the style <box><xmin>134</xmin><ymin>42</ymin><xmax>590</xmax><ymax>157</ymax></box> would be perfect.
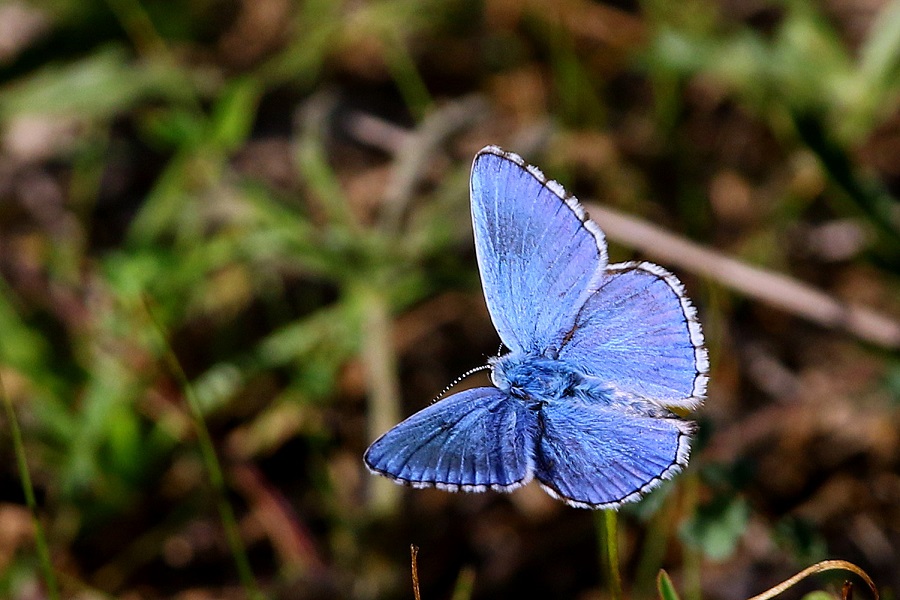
<box><xmin>585</xmin><ymin>203</ymin><xmax>900</xmax><ymax>349</ymax></box>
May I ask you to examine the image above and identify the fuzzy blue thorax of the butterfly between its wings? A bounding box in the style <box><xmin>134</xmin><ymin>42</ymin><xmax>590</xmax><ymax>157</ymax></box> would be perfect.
<box><xmin>491</xmin><ymin>352</ymin><xmax>585</xmax><ymax>408</ymax></box>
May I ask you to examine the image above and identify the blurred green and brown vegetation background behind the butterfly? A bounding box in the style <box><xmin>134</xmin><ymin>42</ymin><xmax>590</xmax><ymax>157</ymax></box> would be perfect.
<box><xmin>0</xmin><ymin>0</ymin><xmax>900</xmax><ymax>600</ymax></box>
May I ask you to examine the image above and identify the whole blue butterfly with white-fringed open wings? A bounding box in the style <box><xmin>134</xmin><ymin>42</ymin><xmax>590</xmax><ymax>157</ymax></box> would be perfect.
<box><xmin>365</xmin><ymin>146</ymin><xmax>709</xmax><ymax>508</ymax></box>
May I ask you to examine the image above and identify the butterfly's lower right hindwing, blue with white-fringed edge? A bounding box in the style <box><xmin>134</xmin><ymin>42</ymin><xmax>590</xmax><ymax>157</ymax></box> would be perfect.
<box><xmin>534</xmin><ymin>402</ymin><xmax>692</xmax><ymax>508</ymax></box>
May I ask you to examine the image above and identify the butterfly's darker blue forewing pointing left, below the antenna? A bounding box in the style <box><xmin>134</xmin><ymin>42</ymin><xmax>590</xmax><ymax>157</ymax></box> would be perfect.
<box><xmin>365</xmin><ymin>388</ymin><xmax>537</xmax><ymax>492</ymax></box>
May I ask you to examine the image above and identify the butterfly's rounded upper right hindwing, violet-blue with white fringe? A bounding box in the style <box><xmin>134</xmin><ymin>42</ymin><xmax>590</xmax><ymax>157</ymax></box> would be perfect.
<box><xmin>559</xmin><ymin>262</ymin><xmax>709</xmax><ymax>408</ymax></box>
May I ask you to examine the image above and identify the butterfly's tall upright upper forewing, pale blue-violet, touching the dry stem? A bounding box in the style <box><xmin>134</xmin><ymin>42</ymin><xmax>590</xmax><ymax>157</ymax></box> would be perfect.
<box><xmin>471</xmin><ymin>146</ymin><xmax>607</xmax><ymax>356</ymax></box>
